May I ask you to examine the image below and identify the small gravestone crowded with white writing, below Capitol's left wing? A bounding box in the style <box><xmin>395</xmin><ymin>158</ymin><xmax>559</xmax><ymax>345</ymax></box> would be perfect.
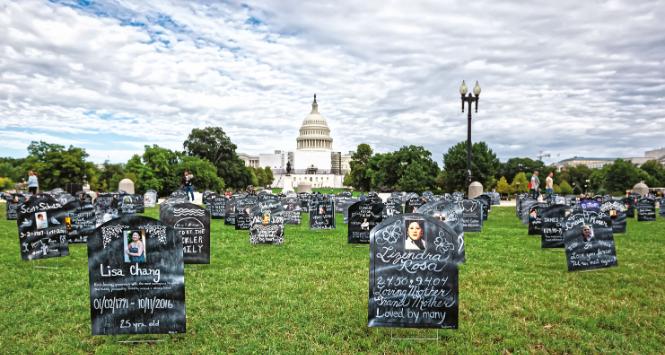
<box><xmin>249</xmin><ymin>206</ymin><xmax>284</xmax><ymax>244</ymax></box>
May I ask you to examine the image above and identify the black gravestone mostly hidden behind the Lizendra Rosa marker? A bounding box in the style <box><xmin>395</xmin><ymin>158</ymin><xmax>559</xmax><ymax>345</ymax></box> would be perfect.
<box><xmin>417</xmin><ymin>200</ymin><xmax>466</xmax><ymax>264</ymax></box>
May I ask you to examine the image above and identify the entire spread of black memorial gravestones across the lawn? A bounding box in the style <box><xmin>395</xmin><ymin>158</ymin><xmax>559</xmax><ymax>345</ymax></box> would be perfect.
<box><xmin>3</xmin><ymin>189</ymin><xmax>665</xmax><ymax>335</ymax></box>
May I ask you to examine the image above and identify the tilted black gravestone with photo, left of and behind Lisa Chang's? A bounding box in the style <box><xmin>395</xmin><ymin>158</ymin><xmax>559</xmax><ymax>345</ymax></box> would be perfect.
<box><xmin>16</xmin><ymin>194</ymin><xmax>69</xmax><ymax>260</ymax></box>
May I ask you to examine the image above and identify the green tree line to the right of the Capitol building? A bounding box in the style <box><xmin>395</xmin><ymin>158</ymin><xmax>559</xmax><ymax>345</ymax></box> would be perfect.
<box><xmin>344</xmin><ymin>141</ymin><xmax>665</xmax><ymax>195</ymax></box>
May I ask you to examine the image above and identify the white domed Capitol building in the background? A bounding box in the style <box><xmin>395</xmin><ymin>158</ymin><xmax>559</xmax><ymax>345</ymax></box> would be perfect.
<box><xmin>238</xmin><ymin>94</ymin><xmax>351</xmax><ymax>191</ymax></box>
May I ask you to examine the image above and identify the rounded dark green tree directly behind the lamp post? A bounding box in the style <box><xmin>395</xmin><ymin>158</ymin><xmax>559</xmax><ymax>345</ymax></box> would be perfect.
<box><xmin>443</xmin><ymin>142</ymin><xmax>501</xmax><ymax>192</ymax></box>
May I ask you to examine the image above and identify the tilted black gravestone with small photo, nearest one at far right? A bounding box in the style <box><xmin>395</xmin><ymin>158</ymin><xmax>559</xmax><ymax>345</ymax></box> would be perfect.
<box><xmin>563</xmin><ymin>210</ymin><xmax>617</xmax><ymax>271</ymax></box>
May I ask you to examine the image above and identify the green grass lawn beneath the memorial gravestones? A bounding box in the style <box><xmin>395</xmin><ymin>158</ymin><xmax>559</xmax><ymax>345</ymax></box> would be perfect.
<box><xmin>0</xmin><ymin>206</ymin><xmax>665</xmax><ymax>354</ymax></box>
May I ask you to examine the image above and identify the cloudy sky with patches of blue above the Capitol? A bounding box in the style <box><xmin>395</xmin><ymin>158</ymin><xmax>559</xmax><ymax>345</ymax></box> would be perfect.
<box><xmin>0</xmin><ymin>0</ymin><xmax>665</xmax><ymax>164</ymax></box>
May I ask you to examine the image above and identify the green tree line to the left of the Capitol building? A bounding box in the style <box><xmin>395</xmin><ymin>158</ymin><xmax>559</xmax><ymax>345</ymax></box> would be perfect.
<box><xmin>0</xmin><ymin>127</ymin><xmax>273</xmax><ymax>196</ymax></box>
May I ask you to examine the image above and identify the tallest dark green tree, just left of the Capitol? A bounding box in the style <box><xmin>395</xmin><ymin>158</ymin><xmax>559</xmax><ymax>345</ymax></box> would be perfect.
<box><xmin>183</xmin><ymin>127</ymin><xmax>252</xmax><ymax>189</ymax></box>
